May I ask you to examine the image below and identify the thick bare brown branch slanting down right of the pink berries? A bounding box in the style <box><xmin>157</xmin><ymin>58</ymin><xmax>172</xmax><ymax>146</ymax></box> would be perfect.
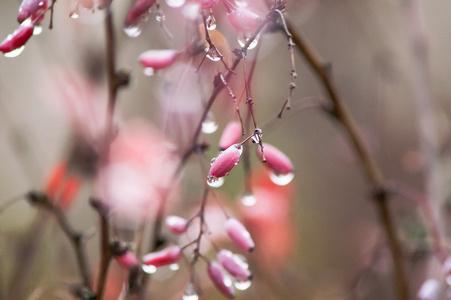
<box><xmin>286</xmin><ymin>20</ymin><xmax>409</xmax><ymax>300</ymax></box>
